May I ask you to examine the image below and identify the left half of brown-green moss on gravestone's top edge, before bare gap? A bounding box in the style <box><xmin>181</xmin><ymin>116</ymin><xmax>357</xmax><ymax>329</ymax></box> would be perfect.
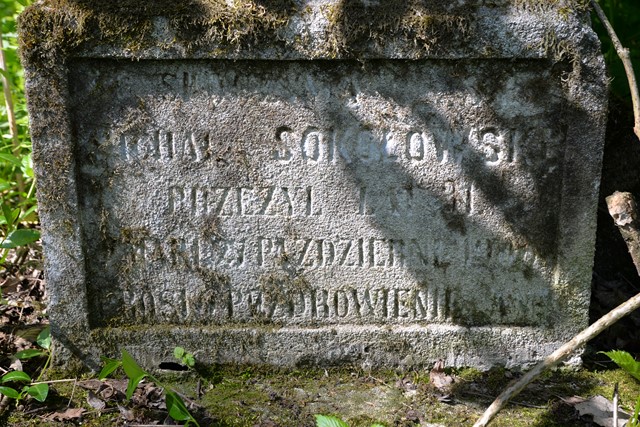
<box><xmin>19</xmin><ymin>0</ymin><xmax>294</xmax><ymax>65</ymax></box>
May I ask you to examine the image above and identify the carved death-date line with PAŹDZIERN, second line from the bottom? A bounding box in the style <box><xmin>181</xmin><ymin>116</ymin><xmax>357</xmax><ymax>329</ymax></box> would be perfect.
<box><xmin>131</xmin><ymin>236</ymin><xmax>544</xmax><ymax>271</ymax></box>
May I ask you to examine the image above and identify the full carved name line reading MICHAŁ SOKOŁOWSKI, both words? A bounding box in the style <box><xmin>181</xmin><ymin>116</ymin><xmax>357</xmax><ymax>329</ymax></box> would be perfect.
<box><xmin>105</xmin><ymin>126</ymin><xmax>561</xmax><ymax>169</ymax></box>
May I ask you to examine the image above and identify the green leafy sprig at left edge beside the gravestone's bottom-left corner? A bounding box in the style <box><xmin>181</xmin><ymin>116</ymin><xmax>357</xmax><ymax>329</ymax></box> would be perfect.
<box><xmin>0</xmin><ymin>327</ymin><xmax>52</xmax><ymax>403</ymax></box>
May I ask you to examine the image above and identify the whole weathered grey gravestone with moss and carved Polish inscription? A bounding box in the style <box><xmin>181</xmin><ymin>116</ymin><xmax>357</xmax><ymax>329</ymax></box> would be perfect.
<box><xmin>20</xmin><ymin>0</ymin><xmax>607</xmax><ymax>368</ymax></box>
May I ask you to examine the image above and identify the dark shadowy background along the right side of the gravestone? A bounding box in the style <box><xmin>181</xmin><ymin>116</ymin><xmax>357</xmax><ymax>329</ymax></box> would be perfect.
<box><xmin>590</xmin><ymin>0</ymin><xmax>640</xmax><ymax>356</ymax></box>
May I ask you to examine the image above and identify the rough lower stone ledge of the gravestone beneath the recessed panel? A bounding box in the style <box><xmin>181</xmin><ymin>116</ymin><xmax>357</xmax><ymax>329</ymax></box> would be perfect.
<box><xmin>81</xmin><ymin>326</ymin><xmax>579</xmax><ymax>370</ymax></box>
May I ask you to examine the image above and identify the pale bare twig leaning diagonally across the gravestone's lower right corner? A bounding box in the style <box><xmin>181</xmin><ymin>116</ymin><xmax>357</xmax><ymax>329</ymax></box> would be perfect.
<box><xmin>473</xmin><ymin>293</ymin><xmax>640</xmax><ymax>427</ymax></box>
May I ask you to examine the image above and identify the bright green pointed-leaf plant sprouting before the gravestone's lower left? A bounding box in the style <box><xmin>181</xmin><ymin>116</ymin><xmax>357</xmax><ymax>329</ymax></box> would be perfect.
<box><xmin>98</xmin><ymin>347</ymin><xmax>199</xmax><ymax>427</ymax></box>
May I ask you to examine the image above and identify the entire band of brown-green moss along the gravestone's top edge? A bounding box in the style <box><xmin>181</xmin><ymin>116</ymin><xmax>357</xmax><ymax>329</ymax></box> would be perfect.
<box><xmin>19</xmin><ymin>0</ymin><xmax>588</xmax><ymax>66</ymax></box>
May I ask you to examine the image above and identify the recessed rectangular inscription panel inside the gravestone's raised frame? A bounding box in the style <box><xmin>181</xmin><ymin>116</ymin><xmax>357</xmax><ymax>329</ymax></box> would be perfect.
<box><xmin>69</xmin><ymin>59</ymin><xmax>567</xmax><ymax>327</ymax></box>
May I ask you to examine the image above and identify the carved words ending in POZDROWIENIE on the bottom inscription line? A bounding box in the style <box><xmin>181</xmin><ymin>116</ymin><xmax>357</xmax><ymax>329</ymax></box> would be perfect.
<box><xmin>124</xmin><ymin>287</ymin><xmax>453</xmax><ymax>323</ymax></box>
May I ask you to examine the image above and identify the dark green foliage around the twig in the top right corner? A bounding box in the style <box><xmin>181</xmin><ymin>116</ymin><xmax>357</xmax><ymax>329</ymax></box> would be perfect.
<box><xmin>593</xmin><ymin>0</ymin><xmax>640</xmax><ymax>103</ymax></box>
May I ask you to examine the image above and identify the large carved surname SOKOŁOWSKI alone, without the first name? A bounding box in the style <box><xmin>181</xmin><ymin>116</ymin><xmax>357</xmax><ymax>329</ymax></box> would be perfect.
<box><xmin>272</xmin><ymin>126</ymin><xmax>524</xmax><ymax>166</ymax></box>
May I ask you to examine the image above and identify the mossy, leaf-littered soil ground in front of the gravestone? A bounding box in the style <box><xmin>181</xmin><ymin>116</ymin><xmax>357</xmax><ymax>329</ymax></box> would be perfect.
<box><xmin>0</xmin><ymin>350</ymin><xmax>640</xmax><ymax>427</ymax></box>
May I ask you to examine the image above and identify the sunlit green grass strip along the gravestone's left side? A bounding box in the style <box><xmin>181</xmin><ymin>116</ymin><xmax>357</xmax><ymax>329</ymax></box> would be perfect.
<box><xmin>0</xmin><ymin>0</ymin><xmax>40</xmax><ymax>261</ymax></box>
